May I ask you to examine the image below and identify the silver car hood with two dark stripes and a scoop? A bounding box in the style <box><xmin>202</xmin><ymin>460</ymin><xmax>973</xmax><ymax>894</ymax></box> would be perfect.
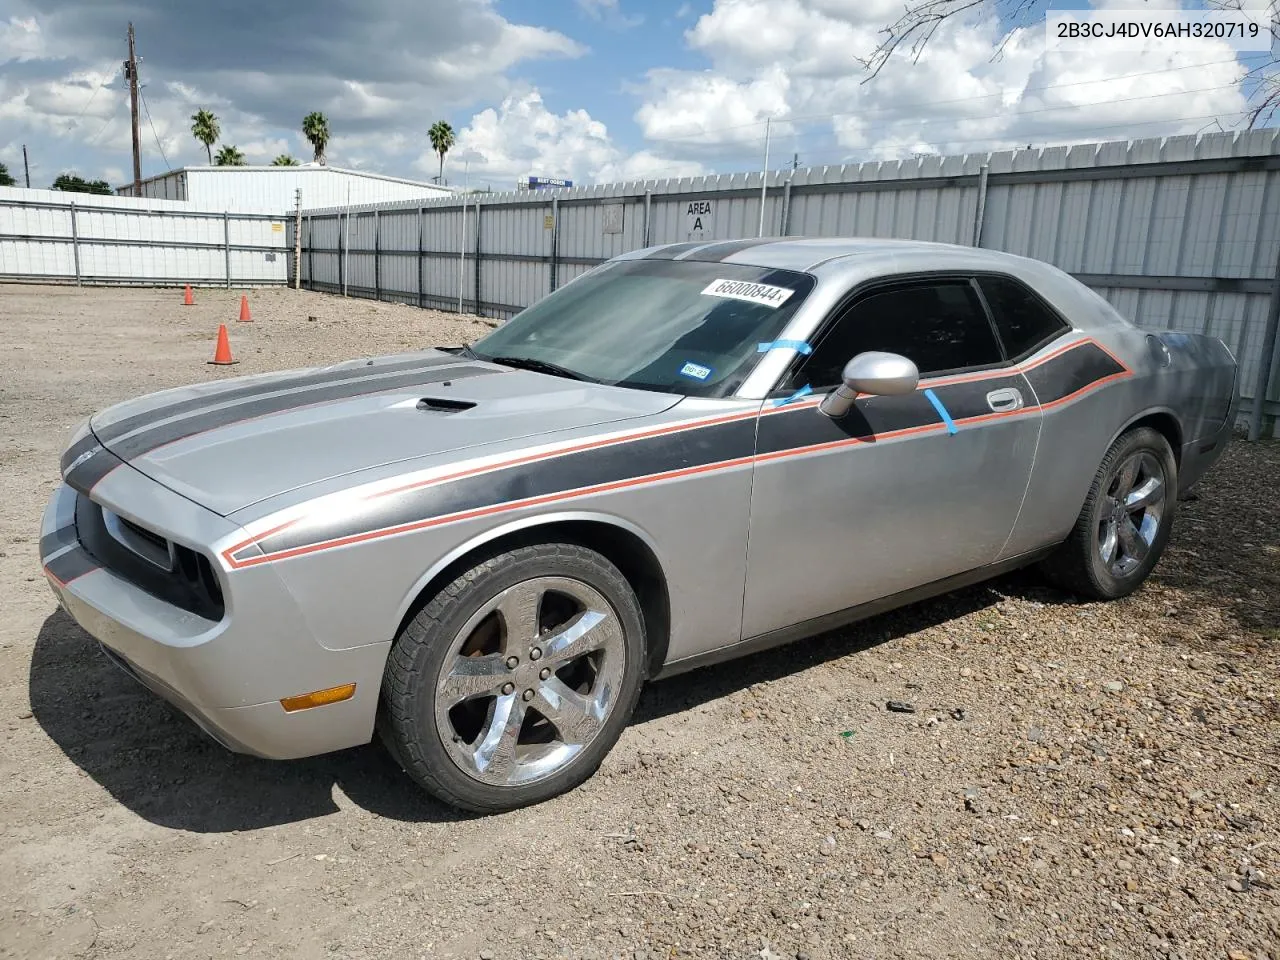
<box><xmin>90</xmin><ymin>349</ymin><xmax>680</xmax><ymax>516</ymax></box>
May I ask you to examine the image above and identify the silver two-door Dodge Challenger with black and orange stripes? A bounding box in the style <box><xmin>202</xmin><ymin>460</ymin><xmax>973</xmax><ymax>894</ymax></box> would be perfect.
<box><xmin>40</xmin><ymin>239</ymin><xmax>1239</xmax><ymax>810</ymax></box>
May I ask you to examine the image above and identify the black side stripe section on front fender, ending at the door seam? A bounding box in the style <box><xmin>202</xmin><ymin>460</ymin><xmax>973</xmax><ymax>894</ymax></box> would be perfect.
<box><xmin>259</xmin><ymin>419</ymin><xmax>755</xmax><ymax>554</ymax></box>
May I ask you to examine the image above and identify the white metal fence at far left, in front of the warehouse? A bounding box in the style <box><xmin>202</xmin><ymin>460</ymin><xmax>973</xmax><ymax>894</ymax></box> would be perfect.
<box><xmin>0</xmin><ymin>187</ymin><xmax>289</xmax><ymax>287</ymax></box>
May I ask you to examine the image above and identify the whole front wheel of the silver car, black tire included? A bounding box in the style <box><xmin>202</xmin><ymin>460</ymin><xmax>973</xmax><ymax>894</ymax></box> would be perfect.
<box><xmin>378</xmin><ymin>544</ymin><xmax>648</xmax><ymax>813</ymax></box>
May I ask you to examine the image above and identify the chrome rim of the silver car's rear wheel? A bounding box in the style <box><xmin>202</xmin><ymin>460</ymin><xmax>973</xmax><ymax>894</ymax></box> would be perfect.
<box><xmin>1098</xmin><ymin>451</ymin><xmax>1166</xmax><ymax>579</ymax></box>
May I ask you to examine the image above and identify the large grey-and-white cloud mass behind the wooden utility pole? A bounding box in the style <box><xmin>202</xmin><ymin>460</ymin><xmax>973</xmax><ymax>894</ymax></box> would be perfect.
<box><xmin>0</xmin><ymin>0</ymin><xmax>586</xmax><ymax>182</ymax></box>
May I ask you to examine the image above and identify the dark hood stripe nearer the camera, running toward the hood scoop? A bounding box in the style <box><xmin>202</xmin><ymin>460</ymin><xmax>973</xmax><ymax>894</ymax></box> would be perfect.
<box><xmin>104</xmin><ymin>366</ymin><xmax>502</xmax><ymax>463</ymax></box>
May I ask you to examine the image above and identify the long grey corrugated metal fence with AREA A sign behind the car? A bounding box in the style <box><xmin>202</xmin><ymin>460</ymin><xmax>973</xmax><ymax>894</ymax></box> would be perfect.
<box><xmin>301</xmin><ymin>129</ymin><xmax>1280</xmax><ymax>440</ymax></box>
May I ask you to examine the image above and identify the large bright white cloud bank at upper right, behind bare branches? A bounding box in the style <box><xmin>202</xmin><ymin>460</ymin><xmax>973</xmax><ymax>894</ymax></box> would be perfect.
<box><xmin>635</xmin><ymin>0</ymin><xmax>1266</xmax><ymax>166</ymax></box>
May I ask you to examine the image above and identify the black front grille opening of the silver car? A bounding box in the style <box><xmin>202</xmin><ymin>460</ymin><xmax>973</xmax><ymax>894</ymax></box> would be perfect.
<box><xmin>76</xmin><ymin>493</ymin><xmax>225</xmax><ymax>621</ymax></box>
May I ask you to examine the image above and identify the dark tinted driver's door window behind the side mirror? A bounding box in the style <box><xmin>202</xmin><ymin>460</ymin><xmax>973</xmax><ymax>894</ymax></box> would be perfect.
<box><xmin>792</xmin><ymin>280</ymin><xmax>1005</xmax><ymax>390</ymax></box>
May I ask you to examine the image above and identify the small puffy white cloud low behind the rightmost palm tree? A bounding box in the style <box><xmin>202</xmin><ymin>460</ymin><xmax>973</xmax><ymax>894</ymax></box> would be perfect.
<box><xmin>435</xmin><ymin>90</ymin><xmax>704</xmax><ymax>189</ymax></box>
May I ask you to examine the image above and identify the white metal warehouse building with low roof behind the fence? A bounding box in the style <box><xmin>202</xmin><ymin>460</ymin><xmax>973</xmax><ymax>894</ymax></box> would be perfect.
<box><xmin>115</xmin><ymin>164</ymin><xmax>453</xmax><ymax>212</ymax></box>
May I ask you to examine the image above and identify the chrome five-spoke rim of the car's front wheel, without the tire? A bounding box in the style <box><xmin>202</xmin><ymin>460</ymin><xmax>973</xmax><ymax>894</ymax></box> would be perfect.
<box><xmin>435</xmin><ymin>577</ymin><xmax>626</xmax><ymax>786</ymax></box>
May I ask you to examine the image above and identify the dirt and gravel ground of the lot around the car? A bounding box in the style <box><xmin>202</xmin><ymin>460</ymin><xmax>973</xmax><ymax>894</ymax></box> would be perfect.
<box><xmin>0</xmin><ymin>285</ymin><xmax>1280</xmax><ymax>960</ymax></box>
